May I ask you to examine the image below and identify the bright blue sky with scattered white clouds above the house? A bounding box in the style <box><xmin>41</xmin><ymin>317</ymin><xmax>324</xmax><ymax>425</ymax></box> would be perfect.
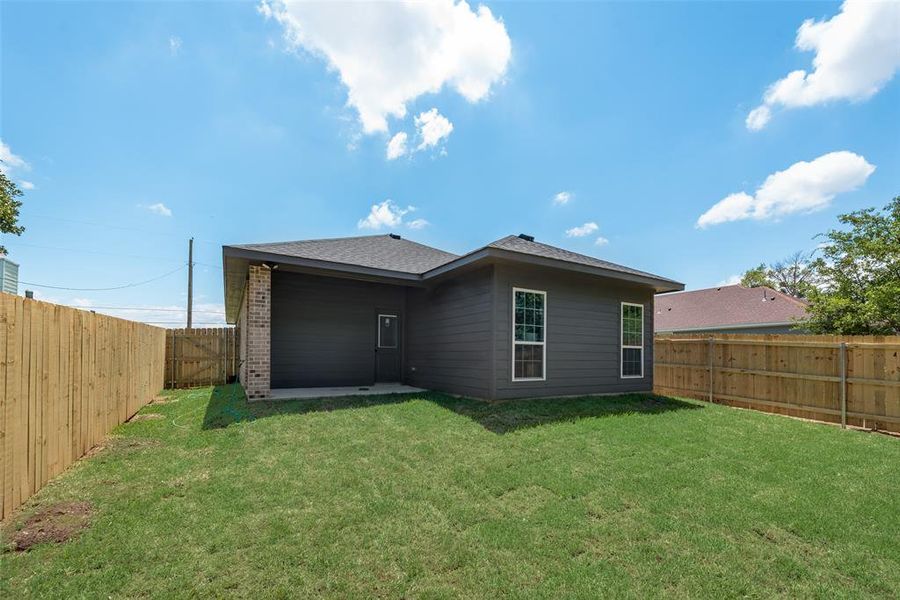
<box><xmin>0</xmin><ymin>2</ymin><xmax>900</xmax><ymax>325</ymax></box>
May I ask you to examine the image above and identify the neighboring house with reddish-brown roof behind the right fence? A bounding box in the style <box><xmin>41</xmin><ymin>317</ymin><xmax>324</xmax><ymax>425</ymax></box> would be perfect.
<box><xmin>653</xmin><ymin>285</ymin><xmax>807</xmax><ymax>333</ymax></box>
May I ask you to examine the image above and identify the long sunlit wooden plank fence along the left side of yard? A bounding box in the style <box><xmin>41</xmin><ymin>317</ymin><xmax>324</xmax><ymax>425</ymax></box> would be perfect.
<box><xmin>0</xmin><ymin>294</ymin><xmax>165</xmax><ymax>519</ymax></box>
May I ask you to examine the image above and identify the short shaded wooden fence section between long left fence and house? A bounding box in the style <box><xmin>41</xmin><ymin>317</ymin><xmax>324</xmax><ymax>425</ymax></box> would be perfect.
<box><xmin>166</xmin><ymin>327</ymin><xmax>240</xmax><ymax>388</ymax></box>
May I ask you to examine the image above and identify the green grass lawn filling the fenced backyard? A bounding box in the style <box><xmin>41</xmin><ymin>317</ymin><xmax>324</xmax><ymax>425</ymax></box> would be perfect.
<box><xmin>0</xmin><ymin>387</ymin><xmax>900</xmax><ymax>598</ymax></box>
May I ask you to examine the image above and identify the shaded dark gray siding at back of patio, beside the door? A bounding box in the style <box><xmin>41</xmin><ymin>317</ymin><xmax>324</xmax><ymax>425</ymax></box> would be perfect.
<box><xmin>271</xmin><ymin>271</ymin><xmax>405</xmax><ymax>388</ymax></box>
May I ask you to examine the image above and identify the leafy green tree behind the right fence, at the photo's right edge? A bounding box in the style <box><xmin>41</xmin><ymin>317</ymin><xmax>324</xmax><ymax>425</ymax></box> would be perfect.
<box><xmin>808</xmin><ymin>196</ymin><xmax>900</xmax><ymax>335</ymax></box>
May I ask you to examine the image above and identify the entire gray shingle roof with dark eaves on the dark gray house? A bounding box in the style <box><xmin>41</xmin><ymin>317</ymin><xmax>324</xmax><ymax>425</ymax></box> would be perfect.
<box><xmin>222</xmin><ymin>234</ymin><xmax>684</xmax><ymax>323</ymax></box>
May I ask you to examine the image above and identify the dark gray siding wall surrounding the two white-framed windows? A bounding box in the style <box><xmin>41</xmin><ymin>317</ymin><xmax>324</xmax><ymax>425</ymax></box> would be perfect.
<box><xmin>494</xmin><ymin>265</ymin><xmax>653</xmax><ymax>398</ymax></box>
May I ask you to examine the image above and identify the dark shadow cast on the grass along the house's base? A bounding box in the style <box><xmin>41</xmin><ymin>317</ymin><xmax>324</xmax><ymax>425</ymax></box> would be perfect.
<box><xmin>203</xmin><ymin>384</ymin><xmax>702</xmax><ymax>434</ymax></box>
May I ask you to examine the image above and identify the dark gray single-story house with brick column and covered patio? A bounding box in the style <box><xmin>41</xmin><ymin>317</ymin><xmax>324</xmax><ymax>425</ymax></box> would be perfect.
<box><xmin>223</xmin><ymin>234</ymin><xmax>684</xmax><ymax>399</ymax></box>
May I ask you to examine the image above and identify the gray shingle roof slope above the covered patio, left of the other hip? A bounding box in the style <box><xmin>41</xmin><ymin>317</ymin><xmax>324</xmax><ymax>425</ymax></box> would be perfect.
<box><xmin>231</xmin><ymin>234</ymin><xmax>457</xmax><ymax>274</ymax></box>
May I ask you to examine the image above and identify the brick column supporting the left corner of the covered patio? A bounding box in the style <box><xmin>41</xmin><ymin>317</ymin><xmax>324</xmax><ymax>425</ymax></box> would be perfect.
<box><xmin>242</xmin><ymin>265</ymin><xmax>272</xmax><ymax>400</ymax></box>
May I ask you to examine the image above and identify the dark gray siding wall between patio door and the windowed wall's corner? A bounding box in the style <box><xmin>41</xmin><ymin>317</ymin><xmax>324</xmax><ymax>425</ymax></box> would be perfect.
<box><xmin>405</xmin><ymin>267</ymin><xmax>492</xmax><ymax>398</ymax></box>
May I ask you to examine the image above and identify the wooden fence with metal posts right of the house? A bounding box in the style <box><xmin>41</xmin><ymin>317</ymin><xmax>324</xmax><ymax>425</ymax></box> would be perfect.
<box><xmin>653</xmin><ymin>334</ymin><xmax>900</xmax><ymax>431</ymax></box>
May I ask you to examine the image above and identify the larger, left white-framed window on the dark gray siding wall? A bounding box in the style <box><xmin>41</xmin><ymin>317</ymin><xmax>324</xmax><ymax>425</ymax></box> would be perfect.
<box><xmin>512</xmin><ymin>288</ymin><xmax>547</xmax><ymax>381</ymax></box>
